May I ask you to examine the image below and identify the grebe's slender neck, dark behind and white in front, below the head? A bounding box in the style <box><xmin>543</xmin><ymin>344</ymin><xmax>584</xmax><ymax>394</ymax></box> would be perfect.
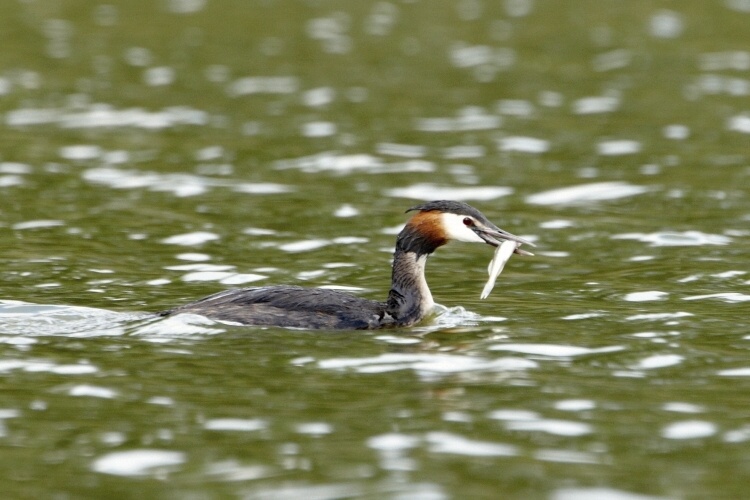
<box><xmin>386</xmin><ymin>244</ymin><xmax>435</xmax><ymax>326</ymax></box>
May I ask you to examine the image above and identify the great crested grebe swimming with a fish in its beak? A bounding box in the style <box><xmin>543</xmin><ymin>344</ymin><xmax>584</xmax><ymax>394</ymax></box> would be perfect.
<box><xmin>160</xmin><ymin>200</ymin><xmax>534</xmax><ymax>330</ymax></box>
